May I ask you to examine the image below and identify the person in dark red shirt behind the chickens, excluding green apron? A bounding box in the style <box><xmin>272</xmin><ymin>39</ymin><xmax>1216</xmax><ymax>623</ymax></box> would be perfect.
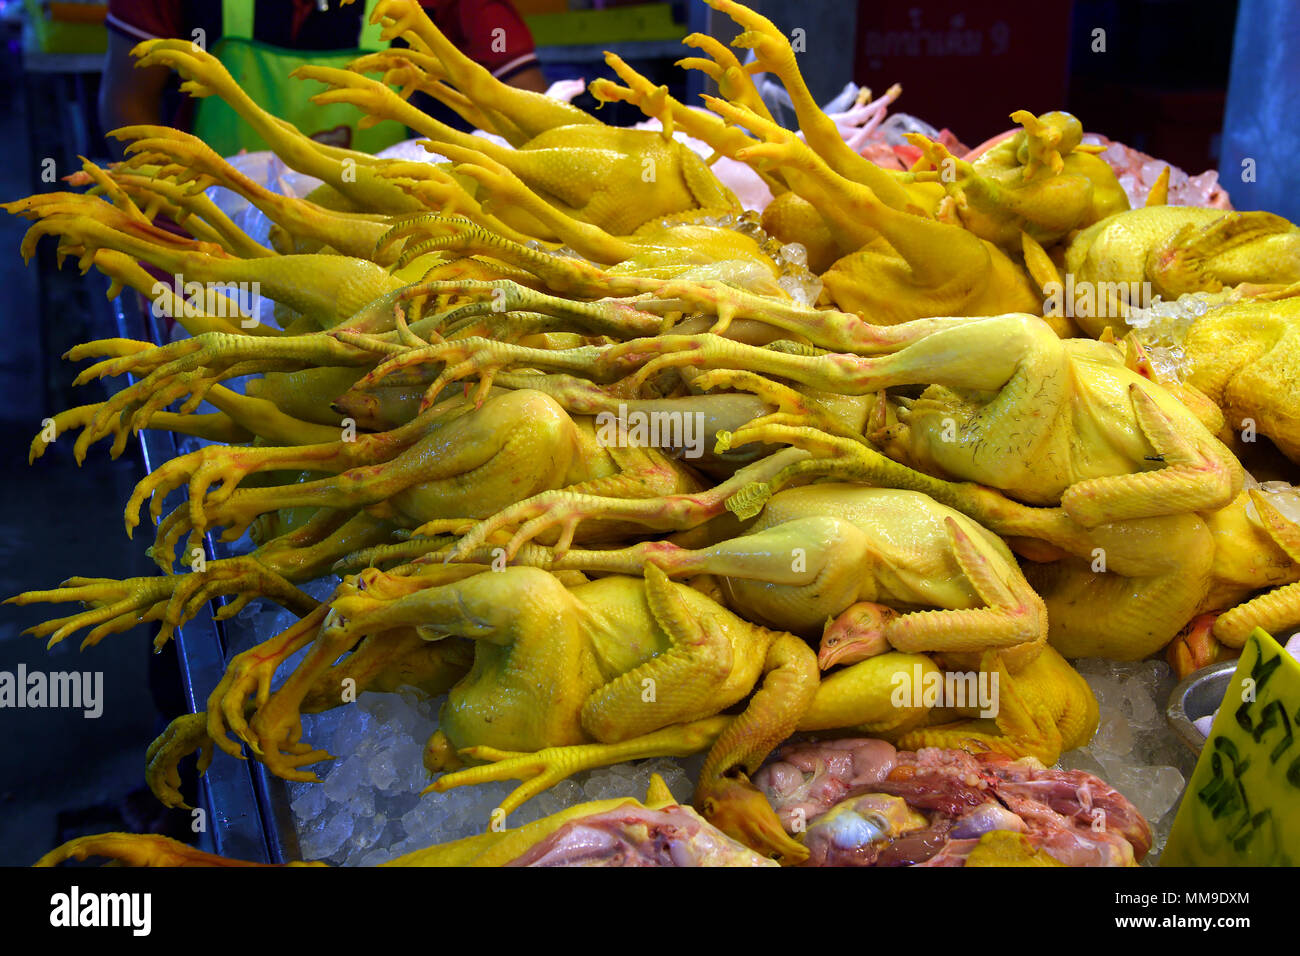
<box><xmin>99</xmin><ymin>0</ymin><xmax>546</xmax><ymax>151</ymax></box>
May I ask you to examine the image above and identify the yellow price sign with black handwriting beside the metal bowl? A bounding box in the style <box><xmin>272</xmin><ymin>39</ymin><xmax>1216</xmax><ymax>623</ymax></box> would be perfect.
<box><xmin>1160</xmin><ymin>628</ymin><xmax>1300</xmax><ymax>866</ymax></box>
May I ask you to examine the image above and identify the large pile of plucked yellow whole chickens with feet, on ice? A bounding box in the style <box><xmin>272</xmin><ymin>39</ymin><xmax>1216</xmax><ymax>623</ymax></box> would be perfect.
<box><xmin>5</xmin><ymin>0</ymin><xmax>1300</xmax><ymax>865</ymax></box>
